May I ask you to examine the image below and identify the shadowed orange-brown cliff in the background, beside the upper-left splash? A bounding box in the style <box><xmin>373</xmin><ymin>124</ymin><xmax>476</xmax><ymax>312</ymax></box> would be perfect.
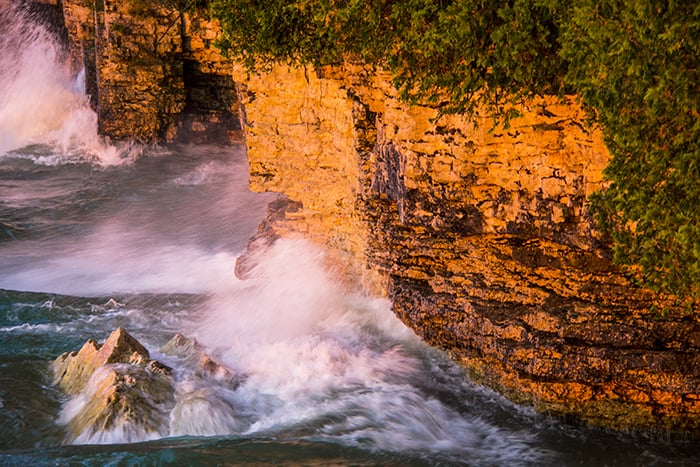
<box><xmin>63</xmin><ymin>0</ymin><xmax>242</xmax><ymax>144</ymax></box>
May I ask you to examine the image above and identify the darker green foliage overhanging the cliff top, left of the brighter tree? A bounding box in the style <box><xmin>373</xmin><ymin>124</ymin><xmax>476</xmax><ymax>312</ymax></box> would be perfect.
<box><xmin>210</xmin><ymin>0</ymin><xmax>563</xmax><ymax>114</ymax></box>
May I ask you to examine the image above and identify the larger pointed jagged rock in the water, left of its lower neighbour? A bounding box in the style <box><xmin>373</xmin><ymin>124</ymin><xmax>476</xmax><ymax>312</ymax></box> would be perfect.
<box><xmin>52</xmin><ymin>328</ymin><xmax>175</xmax><ymax>443</ymax></box>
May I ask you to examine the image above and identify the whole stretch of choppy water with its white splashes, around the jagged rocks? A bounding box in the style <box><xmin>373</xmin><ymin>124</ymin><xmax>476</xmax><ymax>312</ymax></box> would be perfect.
<box><xmin>0</xmin><ymin>1</ymin><xmax>700</xmax><ymax>466</ymax></box>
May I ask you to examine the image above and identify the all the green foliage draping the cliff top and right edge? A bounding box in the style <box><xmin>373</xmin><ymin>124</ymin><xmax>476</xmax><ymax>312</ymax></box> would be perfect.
<box><xmin>209</xmin><ymin>0</ymin><xmax>700</xmax><ymax>296</ymax></box>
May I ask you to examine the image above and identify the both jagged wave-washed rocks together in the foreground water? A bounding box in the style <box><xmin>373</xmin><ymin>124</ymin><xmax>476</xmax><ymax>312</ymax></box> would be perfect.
<box><xmin>52</xmin><ymin>328</ymin><xmax>243</xmax><ymax>443</ymax></box>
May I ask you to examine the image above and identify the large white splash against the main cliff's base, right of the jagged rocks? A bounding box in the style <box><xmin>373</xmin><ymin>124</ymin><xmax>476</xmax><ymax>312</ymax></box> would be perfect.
<box><xmin>182</xmin><ymin>240</ymin><xmax>546</xmax><ymax>465</ymax></box>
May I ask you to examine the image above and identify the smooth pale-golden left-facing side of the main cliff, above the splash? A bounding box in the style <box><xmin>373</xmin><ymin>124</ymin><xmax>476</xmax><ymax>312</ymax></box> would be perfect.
<box><xmin>234</xmin><ymin>67</ymin><xmax>381</xmax><ymax>289</ymax></box>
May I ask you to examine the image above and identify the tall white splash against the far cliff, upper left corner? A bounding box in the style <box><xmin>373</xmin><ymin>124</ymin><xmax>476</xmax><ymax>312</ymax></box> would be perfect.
<box><xmin>0</xmin><ymin>5</ymin><xmax>139</xmax><ymax>166</ymax></box>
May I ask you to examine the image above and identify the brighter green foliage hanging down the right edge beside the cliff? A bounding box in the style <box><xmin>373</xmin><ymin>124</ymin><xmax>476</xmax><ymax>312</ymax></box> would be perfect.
<box><xmin>562</xmin><ymin>0</ymin><xmax>700</xmax><ymax>296</ymax></box>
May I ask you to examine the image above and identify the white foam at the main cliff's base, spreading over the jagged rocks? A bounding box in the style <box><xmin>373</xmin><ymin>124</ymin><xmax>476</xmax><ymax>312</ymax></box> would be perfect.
<box><xmin>46</xmin><ymin>240</ymin><xmax>551</xmax><ymax>465</ymax></box>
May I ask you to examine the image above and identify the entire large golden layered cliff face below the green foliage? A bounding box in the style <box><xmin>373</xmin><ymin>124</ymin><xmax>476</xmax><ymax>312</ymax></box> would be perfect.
<box><xmin>234</xmin><ymin>65</ymin><xmax>700</xmax><ymax>431</ymax></box>
